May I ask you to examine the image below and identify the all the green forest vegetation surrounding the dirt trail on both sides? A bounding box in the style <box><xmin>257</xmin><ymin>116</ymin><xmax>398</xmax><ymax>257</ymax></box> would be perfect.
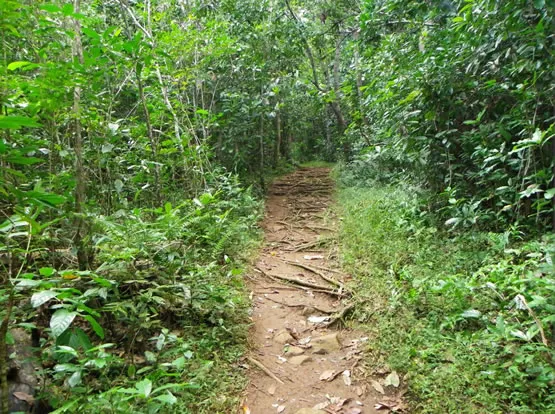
<box><xmin>0</xmin><ymin>0</ymin><xmax>555</xmax><ymax>412</ymax></box>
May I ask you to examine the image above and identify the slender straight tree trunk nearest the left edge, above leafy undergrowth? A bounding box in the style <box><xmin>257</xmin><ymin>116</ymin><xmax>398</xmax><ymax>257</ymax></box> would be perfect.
<box><xmin>73</xmin><ymin>0</ymin><xmax>89</xmax><ymax>270</ymax></box>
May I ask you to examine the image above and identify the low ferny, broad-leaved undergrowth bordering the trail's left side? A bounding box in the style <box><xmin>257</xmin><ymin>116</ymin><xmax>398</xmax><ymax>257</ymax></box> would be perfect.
<box><xmin>0</xmin><ymin>175</ymin><xmax>261</xmax><ymax>413</ymax></box>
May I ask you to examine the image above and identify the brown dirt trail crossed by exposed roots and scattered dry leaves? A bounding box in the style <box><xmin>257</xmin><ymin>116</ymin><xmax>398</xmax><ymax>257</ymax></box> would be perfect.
<box><xmin>243</xmin><ymin>168</ymin><xmax>383</xmax><ymax>414</ymax></box>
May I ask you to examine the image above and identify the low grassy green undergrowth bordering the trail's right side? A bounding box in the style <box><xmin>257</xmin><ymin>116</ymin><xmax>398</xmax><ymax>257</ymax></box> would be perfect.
<box><xmin>339</xmin><ymin>184</ymin><xmax>555</xmax><ymax>414</ymax></box>
